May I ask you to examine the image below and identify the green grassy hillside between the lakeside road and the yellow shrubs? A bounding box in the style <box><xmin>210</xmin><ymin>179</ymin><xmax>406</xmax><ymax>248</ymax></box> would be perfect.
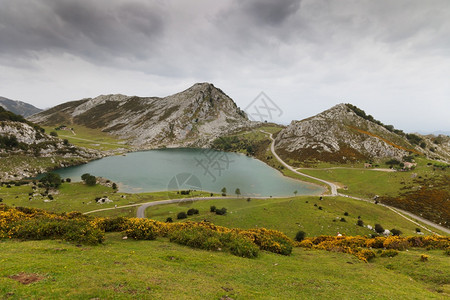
<box><xmin>128</xmin><ymin>197</ymin><xmax>445</xmax><ymax>238</ymax></box>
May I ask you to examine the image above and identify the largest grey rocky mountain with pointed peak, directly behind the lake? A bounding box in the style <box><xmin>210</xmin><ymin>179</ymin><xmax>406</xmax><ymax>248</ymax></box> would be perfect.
<box><xmin>30</xmin><ymin>83</ymin><xmax>251</xmax><ymax>147</ymax></box>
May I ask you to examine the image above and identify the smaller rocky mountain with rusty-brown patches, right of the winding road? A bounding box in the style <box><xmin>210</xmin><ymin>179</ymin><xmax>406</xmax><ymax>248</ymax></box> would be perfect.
<box><xmin>275</xmin><ymin>104</ymin><xmax>448</xmax><ymax>162</ymax></box>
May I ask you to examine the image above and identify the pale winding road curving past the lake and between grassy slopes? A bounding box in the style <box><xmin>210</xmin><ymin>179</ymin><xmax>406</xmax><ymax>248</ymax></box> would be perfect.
<box><xmin>84</xmin><ymin>130</ymin><xmax>450</xmax><ymax>234</ymax></box>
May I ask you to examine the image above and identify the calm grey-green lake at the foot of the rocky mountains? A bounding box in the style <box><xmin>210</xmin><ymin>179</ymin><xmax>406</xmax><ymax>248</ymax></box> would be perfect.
<box><xmin>54</xmin><ymin>148</ymin><xmax>325</xmax><ymax>197</ymax></box>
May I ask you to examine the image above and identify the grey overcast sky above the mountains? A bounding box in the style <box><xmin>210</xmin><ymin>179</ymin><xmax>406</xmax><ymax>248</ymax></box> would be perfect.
<box><xmin>0</xmin><ymin>0</ymin><xmax>450</xmax><ymax>132</ymax></box>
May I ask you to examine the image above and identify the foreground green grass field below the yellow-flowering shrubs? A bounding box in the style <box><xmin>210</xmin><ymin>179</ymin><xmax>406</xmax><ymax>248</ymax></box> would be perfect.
<box><xmin>0</xmin><ymin>234</ymin><xmax>450</xmax><ymax>299</ymax></box>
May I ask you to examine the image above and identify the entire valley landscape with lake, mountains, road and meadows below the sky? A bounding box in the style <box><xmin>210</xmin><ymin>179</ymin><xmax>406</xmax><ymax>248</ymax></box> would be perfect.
<box><xmin>0</xmin><ymin>83</ymin><xmax>450</xmax><ymax>299</ymax></box>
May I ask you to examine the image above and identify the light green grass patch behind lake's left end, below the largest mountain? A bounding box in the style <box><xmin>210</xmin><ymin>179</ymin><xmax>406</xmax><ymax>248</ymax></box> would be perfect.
<box><xmin>44</xmin><ymin>125</ymin><xmax>130</xmax><ymax>151</ymax></box>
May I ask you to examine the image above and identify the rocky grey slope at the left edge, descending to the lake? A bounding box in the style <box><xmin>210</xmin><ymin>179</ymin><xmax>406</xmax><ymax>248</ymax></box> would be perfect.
<box><xmin>0</xmin><ymin>107</ymin><xmax>102</xmax><ymax>181</ymax></box>
